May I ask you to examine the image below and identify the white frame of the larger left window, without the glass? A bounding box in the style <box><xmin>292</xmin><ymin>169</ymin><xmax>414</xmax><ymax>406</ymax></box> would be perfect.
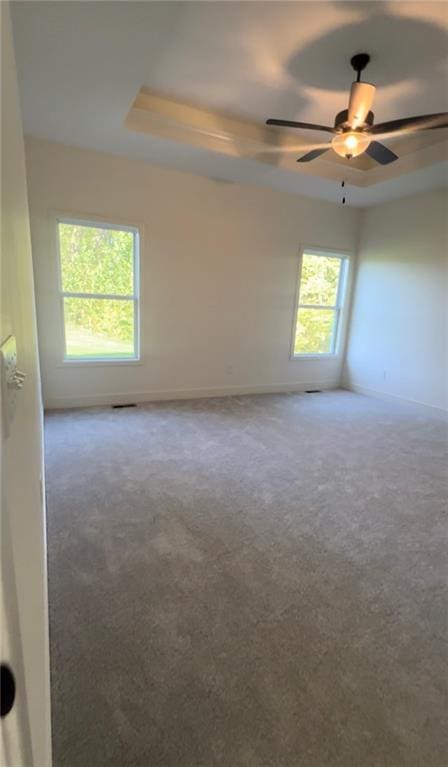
<box><xmin>55</xmin><ymin>213</ymin><xmax>142</xmax><ymax>367</ymax></box>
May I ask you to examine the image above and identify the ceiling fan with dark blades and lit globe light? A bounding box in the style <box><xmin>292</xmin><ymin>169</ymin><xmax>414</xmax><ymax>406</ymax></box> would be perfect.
<box><xmin>266</xmin><ymin>53</ymin><xmax>448</xmax><ymax>165</ymax></box>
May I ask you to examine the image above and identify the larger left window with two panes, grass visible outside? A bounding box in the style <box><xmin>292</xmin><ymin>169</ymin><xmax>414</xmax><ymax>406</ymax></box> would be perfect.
<box><xmin>58</xmin><ymin>219</ymin><xmax>139</xmax><ymax>361</ymax></box>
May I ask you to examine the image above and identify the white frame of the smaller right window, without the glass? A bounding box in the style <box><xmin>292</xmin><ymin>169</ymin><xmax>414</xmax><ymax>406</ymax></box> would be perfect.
<box><xmin>290</xmin><ymin>245</ymin><xmax>352</xmax><ymax>362</ymax></box>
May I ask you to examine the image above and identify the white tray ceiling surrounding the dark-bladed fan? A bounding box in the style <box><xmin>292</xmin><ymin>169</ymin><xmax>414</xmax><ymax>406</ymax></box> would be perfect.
<box><xmin>12</xmin><ymin>0</ymin><xmax>448</xmax><ymax>206</ymax></box>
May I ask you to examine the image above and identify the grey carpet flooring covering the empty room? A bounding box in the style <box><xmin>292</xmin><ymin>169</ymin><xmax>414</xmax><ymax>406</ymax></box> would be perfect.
<box><xmin>46</xmin><ymin>391</ymin><xmax>448</xmax><ymax>767</ymax></box>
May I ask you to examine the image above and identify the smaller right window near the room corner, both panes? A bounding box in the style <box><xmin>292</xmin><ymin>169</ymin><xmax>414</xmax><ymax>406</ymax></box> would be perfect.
<box><xmin>293</xmin><ymin>249</ymin><xmax>348</xmax><ymax>357</ymax></box>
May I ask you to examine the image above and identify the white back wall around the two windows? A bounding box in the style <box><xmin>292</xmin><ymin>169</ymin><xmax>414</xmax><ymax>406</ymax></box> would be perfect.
<box><xmin>27</xmin><ymin>140</ymin><xmax>359</xmax><ymax>406</ymax></box>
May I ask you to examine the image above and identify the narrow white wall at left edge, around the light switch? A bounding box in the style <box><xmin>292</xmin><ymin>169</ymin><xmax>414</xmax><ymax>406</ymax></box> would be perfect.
<box><xmin>0</xmin><ymin>3</ymin><xmax>51</xmax><ymax>767</ymax></box>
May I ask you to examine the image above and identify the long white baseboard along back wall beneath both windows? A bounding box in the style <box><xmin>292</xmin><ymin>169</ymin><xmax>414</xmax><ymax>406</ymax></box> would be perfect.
<box><xmin>45</xmin><ymin>379</ymin><xmax>339</xmax><ymax>410</ymax></box>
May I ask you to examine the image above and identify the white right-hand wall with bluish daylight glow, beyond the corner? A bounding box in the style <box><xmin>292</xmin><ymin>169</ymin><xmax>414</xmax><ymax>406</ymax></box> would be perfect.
<box><xmin>344</xmin><ymin>190</ymin><xmax>448</xmax><ymax>410</ymax></box>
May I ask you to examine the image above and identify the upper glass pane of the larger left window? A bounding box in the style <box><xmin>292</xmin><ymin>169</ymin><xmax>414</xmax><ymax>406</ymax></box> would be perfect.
<box><xmin>59</xmin><ymin>223</ymin><xmax>134</xmax><ymax>296</ymax></box>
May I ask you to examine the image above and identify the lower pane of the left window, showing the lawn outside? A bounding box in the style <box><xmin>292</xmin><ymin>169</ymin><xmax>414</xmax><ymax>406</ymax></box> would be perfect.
<box><xmin>64</xmin><ymin>298</ymin><xmax>135</xmax><ymax>359</ymax></box>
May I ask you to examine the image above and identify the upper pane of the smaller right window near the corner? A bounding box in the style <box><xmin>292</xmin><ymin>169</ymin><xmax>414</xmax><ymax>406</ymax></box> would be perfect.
<box><xmin>300</xmin><ymin>253</ymin><xmax>342</xmax><ymax>306</ymax></box>
